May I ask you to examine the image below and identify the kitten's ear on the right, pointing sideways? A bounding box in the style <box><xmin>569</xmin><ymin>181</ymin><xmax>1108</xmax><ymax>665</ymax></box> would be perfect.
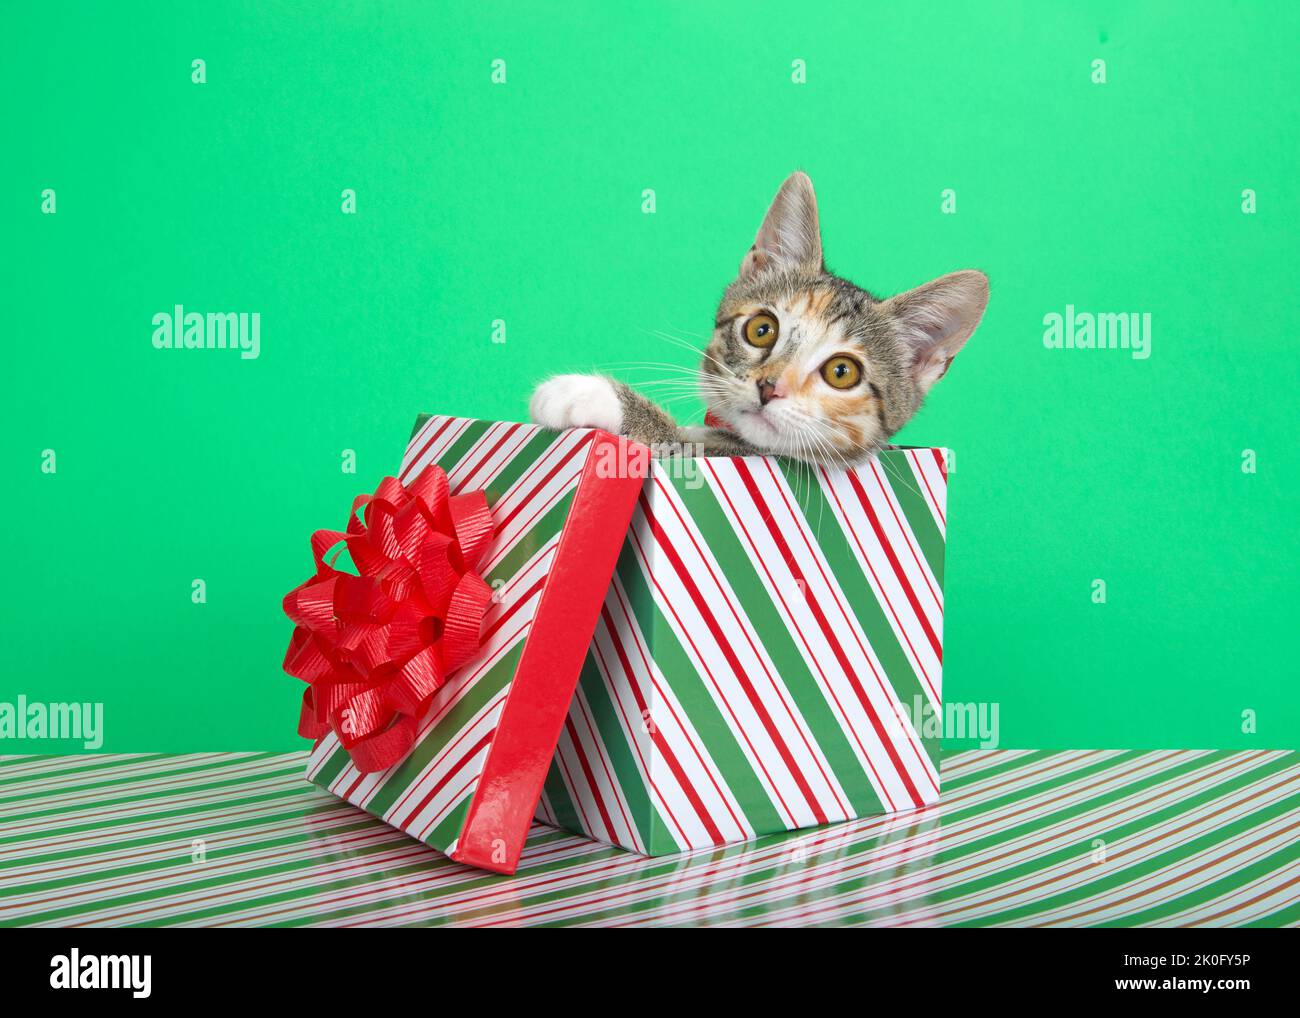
<box><xmin>881</xmin><ymin>269</ymin><xmax>988</xmax><ymax>394</ymax></box>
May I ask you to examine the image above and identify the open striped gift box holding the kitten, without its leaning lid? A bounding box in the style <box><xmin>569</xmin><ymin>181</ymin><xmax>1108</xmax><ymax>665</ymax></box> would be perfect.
<box><xmin>538</xmin><ymin>449</ymin><xmax>946</xmax><ymax>855</ymax></box>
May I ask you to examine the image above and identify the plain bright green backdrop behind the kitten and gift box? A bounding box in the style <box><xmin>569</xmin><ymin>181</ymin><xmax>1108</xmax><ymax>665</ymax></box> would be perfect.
<box><xmin>0</xmin><ymin>3</ymin><xmax>1300</xmax><ymax>751</ymax></box>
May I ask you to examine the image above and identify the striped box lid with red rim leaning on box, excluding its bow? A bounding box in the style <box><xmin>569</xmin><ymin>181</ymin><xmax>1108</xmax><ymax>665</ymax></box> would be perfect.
<box><xmin>308</xmin><ymin>416</ymin><xmax>649</xmax><ymax>872</ymax></box>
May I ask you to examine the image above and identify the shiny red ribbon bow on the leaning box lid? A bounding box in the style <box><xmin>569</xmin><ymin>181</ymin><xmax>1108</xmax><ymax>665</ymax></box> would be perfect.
<box><xmin>285</xmin><ymin>465</ymin><xmax>493</xmax><ymax>771</ymax></box>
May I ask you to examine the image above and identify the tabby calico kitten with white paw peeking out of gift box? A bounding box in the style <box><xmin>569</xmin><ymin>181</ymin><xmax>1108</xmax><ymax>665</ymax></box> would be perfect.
<box><xmin>529</xmin><ymin>173</ymin><xmax>988</xmax><ymax>467</ymax></box>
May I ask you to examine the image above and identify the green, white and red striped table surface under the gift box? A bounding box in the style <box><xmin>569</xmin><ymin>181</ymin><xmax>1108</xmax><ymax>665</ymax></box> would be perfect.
<box><xmin>0</xmin><ymin>750</ymin><xmax>1300</xmax><ymax>926</ymax></box>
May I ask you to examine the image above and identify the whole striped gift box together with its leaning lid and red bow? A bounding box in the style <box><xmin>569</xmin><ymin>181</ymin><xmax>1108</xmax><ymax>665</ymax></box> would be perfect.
<box><xmin>286</xmin><ymin>416</ymin><xmax>946</xmax><ymax>872</ymax></box>
